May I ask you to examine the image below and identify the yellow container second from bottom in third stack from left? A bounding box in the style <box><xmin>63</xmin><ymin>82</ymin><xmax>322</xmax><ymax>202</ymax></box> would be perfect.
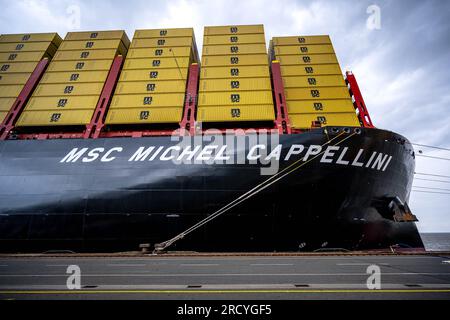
<box><xmin>110</xmin><ymin>93</ymin><xmax>184</xmax><ymax>109</ymax></box>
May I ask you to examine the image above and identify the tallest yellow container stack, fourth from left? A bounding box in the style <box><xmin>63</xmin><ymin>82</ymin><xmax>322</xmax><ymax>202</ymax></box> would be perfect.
<box><xmin>197</xmin><ymin>25</ymin><xmax>275</xmax><ymax>122</ymax></box>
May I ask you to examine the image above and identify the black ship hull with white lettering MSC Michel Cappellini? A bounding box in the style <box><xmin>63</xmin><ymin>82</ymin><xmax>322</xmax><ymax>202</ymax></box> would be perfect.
<box><xmin>0</xmin><ymin>128</ymin><xmax>423</xmax><ymax>252</ymax></box>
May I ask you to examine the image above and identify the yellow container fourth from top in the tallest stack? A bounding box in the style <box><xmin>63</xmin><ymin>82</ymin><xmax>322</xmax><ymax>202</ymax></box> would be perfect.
<box><xmin>202</xmin><ymin>54</ymin><xmax>269</xmax><ymax>67</ymax></box>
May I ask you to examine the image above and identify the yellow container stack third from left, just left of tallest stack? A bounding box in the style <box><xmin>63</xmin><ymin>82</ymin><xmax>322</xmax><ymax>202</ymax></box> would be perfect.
<box><xmin>106</xmin><ymin>28</ymin><xmax>198</xmax><ymax>125</ymax></box>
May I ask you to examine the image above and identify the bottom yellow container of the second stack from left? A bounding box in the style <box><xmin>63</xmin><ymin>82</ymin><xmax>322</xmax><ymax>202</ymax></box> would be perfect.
<box><xmin>16</xmin><ymin>110</ymin><xmax>94</xmax><ymax>127</ymax></box>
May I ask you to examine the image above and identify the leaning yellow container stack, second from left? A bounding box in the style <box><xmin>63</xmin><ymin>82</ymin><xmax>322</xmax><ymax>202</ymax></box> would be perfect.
<box><xmin>16</xmin><ymin>30</ymin><xmax>130</xmax><ymax>127</ymax></box>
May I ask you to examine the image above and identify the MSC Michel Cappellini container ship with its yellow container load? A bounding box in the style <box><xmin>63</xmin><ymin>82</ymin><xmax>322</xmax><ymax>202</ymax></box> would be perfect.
<box><xmin>0</xmin><ymin>25</ymin><xmax>423</xmax><ymax>252</ymax></box>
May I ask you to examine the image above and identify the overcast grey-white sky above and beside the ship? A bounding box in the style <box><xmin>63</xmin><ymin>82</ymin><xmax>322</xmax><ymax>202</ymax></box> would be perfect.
<box><xmin>0</xmin><ymin>0</ymin><xmax>450</xmax><ymax>232</ymax></box>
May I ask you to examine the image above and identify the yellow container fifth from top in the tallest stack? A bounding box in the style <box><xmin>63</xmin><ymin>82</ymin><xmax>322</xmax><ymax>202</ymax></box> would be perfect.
<box><xmin>200</xmin><ymin>66</ymin><xmax>270</xmax><ymax>79</ymax></box>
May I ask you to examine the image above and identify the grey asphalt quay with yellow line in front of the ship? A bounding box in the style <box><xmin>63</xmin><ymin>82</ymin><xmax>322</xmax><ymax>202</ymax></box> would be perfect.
<box><xmin>0</xmin><ymin>254</ymin><xmax>450</xmax><ymax>300</ymax></box>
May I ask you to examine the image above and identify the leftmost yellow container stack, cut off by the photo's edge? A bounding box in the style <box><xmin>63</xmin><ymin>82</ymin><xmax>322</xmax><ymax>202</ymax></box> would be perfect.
<box><xmin>0</xmin><ymin>33</ymin><xmax>62</xmax><ymax>123</ymax></box>
